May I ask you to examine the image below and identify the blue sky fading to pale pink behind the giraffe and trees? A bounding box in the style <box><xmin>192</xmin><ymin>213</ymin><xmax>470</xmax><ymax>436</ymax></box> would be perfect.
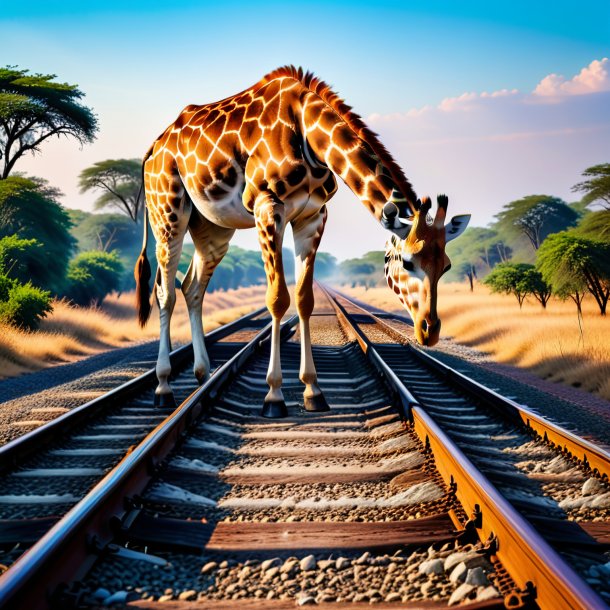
<box><xmin>0</xmin><ymin>0</ymin><xmax>610</xmax><ymax>258</ymax></box>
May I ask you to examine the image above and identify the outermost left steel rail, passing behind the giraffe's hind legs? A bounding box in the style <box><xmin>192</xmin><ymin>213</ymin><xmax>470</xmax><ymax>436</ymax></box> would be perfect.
<box><xmin>0</xmin><ymin>307</ymin><xmax>267</xmax><ymax>474</ymax></box>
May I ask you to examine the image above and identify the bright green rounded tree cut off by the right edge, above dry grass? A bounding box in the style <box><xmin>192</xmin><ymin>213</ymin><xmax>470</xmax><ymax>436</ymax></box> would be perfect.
<box><xmin>537</xmin><ymin>231</ymin><xmax>610</xmax><ymax>315</ymax></box>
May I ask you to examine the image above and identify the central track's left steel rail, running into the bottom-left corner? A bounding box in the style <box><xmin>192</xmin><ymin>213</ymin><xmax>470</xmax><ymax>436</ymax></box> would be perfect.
<box><xmin>0</xmin><ymin>316</ymin><xmax>297</xmax><ymax>610</ymax></box>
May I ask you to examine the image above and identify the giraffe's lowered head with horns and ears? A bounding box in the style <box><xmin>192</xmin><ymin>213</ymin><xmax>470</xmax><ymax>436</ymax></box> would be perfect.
<box><xmin>384</xmin><ymin>195</ymin><xmax>470</xmax><ymax>346</ymax></box>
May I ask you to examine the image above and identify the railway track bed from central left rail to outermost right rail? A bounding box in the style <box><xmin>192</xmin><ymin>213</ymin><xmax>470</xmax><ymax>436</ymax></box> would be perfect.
<box><xmin>0</xmin><ymin>288</ymin><xmax>610</xmax><ymax>610</ymax></box>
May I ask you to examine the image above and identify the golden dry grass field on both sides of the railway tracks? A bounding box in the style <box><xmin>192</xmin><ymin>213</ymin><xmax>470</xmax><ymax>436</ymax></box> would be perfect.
<box><xmin>0</xmin><ymin>283</ymin><xmax>610</xmax><ymax>400</ymax></box>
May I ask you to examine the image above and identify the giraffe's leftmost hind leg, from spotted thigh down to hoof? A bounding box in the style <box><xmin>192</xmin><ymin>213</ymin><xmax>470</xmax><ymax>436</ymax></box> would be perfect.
<box><xmin>147</xmin><ymin>175</ymin><xmax>191</xmax><ymax>406</ymax></box>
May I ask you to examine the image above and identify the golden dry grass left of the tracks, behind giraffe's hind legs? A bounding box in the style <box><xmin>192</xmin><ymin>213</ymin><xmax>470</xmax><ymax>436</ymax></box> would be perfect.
<box><xmin>0</xmin><ymin>286</ymin><xmax>265</xmax><ymax>378</ymax></box>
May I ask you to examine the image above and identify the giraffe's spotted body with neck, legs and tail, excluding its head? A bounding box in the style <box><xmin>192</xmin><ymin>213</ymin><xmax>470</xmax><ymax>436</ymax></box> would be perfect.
<box><xmin>135</xmin><ymin>66</ymin><xmax>470</xmax><ymax>417</ymax></box>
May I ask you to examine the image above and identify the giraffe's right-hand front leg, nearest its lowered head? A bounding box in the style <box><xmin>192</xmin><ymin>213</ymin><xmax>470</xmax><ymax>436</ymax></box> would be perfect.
<box><xmin>292</xmin><ymin>206</ymin><xmax>329</xmax><ymax>411</ymax></box>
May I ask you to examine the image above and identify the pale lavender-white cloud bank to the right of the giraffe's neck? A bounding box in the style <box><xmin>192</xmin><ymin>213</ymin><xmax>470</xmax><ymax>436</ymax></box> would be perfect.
<box><xmin>368</xmin><ymin>59</ymin><xmax>610</xmax><ymax>225</ymax></box>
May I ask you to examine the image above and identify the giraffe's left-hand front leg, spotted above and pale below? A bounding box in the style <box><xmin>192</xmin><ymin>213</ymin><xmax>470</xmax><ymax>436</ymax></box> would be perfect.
<box><xmin>254</xmin><ymin>191</ymin><xmax>290</xmax><ymax>417</ymax></box>
